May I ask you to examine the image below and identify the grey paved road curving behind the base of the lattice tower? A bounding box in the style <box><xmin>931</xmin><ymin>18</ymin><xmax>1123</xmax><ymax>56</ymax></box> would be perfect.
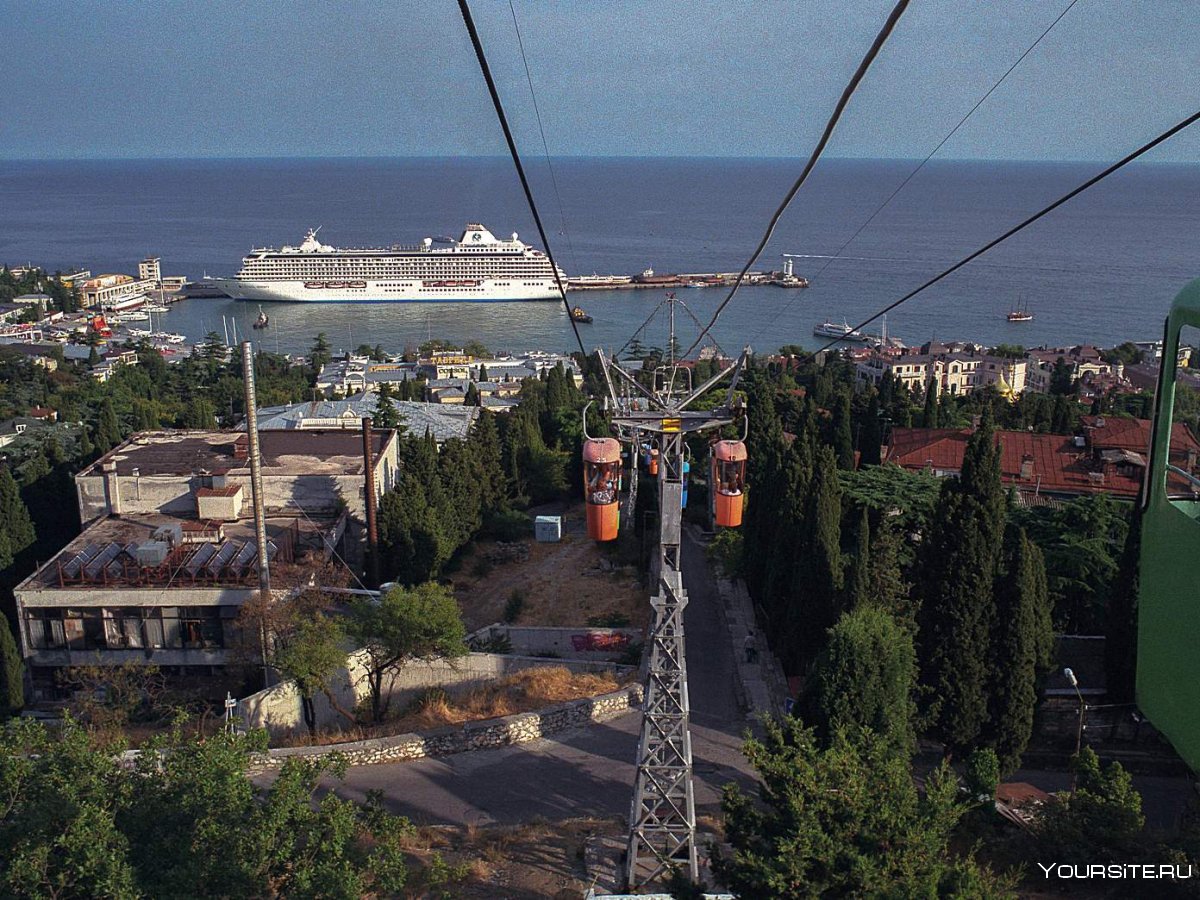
<box><xmin>335</xmin><ymin>528</ymin><xmax>750</xmax><ymax>824</ymax></box>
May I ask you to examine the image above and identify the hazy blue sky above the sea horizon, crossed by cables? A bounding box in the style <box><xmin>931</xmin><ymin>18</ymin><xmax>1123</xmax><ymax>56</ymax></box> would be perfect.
<box><xmin>0</xmin><ymin>0</ymin><xmax>1200</xmax><ymax>162</ymax></box>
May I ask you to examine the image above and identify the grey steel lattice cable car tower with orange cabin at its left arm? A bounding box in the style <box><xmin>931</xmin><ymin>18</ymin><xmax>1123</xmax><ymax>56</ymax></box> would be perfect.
<box><xmin>583</xmin><ymin>295</ymin><xmax>749</xmax><ymax>889</ymax></box>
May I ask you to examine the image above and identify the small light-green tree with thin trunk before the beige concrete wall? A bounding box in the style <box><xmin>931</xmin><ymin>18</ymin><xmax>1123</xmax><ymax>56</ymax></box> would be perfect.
<box><xmin>346</xmin><ymin>582</ymin><xmax>467</xmax><ymax>722</ymax></box>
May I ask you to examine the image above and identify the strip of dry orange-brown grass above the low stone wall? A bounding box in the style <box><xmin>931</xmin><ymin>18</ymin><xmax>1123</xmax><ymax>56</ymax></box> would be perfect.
<box><xmin>277</xmin><ymin>666</ymin><xmax>620</xmax><ymax>746</ymax></box>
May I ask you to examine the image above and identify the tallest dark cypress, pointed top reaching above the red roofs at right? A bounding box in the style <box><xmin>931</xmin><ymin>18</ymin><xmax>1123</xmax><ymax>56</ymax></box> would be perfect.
<box><xmin>917</xmin><ymin>410</ymin><xmax>1006</xmax><ymax>752</ymax></box>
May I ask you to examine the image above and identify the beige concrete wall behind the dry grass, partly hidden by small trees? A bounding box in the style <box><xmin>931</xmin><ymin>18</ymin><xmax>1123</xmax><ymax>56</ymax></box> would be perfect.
<box><xmin>238</xmin><ymin>650</ymin><xmax>624</xmax><ymax>733</ymax></box>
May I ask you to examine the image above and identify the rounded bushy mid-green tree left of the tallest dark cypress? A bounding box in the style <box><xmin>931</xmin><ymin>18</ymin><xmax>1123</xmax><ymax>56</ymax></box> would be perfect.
<box><xmin>808</xmin><ymin>606</ymin><xmax>917</xmax><ymax>755</ymax></box>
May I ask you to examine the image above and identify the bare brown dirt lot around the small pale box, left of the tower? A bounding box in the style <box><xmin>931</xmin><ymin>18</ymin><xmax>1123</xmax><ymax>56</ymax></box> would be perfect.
<box><xmin>451</xmin><ymin>504</ymin><xmax>650</xmax><ymax>631</ymax></box>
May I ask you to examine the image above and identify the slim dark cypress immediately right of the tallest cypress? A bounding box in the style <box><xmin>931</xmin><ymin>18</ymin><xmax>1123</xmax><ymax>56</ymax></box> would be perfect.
<box><xmin>988</xmin><ymin>527</ymin><xmax>1052</xmax><ymax>772</ymax></box>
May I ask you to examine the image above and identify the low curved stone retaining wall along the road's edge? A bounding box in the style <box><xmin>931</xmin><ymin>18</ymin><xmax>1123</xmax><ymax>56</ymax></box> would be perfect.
<box><xmin>238</xmin><ymin>684</ymin><xmax>642</xmax><ymax>773</ymax></box>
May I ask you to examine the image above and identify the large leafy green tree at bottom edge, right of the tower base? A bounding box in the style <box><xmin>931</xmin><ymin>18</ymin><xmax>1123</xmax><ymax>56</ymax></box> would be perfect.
<box><xmin>713</xmin><ymin>718</ymin><xmax>1013</xmax><ymax>900</ymax></box>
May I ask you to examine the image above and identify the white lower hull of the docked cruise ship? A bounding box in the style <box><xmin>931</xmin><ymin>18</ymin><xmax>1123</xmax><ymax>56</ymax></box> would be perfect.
<box><xmin>206</xmin><ymin>277</ymin><xmax>562</xmax><ymax>304</ymax></box>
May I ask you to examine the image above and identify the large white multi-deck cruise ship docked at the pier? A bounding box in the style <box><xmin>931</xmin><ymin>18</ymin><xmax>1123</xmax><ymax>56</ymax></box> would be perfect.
<box><xmin>208</xmin><ymin>223</ymin><xmax>566</xmax><ymax>304</ymax></box>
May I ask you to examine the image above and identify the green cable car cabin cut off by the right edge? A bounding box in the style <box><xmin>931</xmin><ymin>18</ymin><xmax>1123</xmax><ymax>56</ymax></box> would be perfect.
<box><xmin>1136</xmin><ymin>278</ymin><xmax>1200</xmax><ymax>772</ymax></box>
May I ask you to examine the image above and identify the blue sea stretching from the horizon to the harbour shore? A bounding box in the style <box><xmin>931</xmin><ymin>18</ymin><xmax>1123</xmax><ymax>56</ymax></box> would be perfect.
<box><xmin>0</xmin><ymin>157</ymin><xmax>1200</xmax><ymax>354</ymax></box>
